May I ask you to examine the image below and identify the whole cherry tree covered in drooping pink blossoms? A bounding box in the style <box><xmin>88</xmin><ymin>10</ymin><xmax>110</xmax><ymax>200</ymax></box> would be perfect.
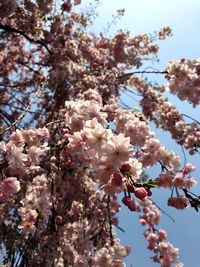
<box><xmin>0</xmin><ymin>0</ymin><xmax>200</xmax><ymax>267</ymax></box>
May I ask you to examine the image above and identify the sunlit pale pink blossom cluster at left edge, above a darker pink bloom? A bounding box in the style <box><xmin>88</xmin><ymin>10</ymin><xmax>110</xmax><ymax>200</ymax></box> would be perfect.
<box><xmin>0</xmin><ymin>128</ymin><xmax>49</xmax><ymax>175</ymax></box>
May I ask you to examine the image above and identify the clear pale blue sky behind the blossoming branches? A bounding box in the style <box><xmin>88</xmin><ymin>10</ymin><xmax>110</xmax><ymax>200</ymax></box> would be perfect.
<box><xmin>83</xmin><ymin>0</ymin><xmax>200</xmax><ymax>267</ymax></box>
